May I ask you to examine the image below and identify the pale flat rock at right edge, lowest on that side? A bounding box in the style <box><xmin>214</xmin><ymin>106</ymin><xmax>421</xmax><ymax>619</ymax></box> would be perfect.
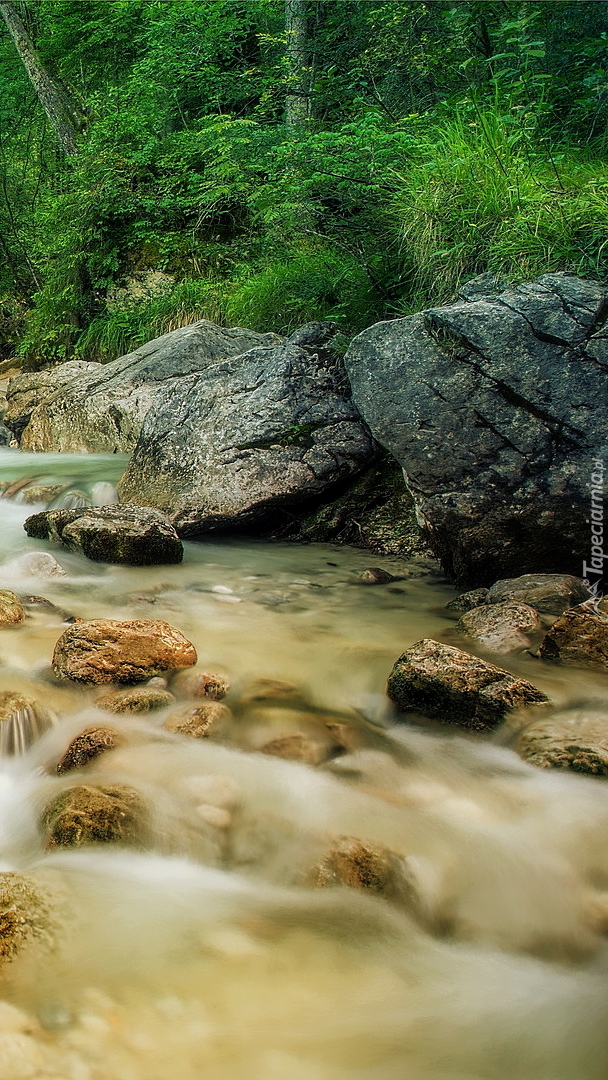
<box><xmin>515</xmin><ymin>707</ymin><xmax>608</xmax><ymax>777</ymax></box>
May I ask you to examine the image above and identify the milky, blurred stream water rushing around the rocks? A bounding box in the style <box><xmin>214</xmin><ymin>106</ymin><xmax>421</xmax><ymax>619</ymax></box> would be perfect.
<box><xmin>0</xmin><ymin>451</ymin><xmax>608</xmax><ymax>1080</ymax></box>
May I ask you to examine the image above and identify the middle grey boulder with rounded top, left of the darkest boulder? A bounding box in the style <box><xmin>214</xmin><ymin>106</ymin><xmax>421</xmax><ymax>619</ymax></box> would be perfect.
<box><xmin>118</xmin><ymin>343</ymin><xmax>376</xmax><ymax>536</ymax></box>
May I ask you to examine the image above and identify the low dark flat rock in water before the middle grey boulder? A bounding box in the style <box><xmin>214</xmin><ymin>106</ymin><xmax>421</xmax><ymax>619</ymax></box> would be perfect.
<box><xmin>24</xmin><ymin>505</ymin><xmax>184</xmax><ymax>566</ymax></box>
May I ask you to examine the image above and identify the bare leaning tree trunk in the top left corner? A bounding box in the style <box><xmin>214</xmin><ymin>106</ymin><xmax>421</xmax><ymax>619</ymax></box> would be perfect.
<box><xmin>0</xmin><ymin>0</ymin><xmax>84</xmax><ymax>156</ymax></box>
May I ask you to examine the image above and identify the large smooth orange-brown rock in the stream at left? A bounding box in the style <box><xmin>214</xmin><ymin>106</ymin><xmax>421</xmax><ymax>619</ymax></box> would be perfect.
<box><xmin>53</xmin><ymin>619</ymin><xmax>197</xmax><ymax>684</ymax></box>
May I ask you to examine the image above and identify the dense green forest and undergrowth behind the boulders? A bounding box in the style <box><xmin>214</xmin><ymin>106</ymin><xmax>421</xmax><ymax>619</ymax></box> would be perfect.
<box><xmin>0</xmin><ymin>0</ymin><xmax>608</xmax><ymax>368</ymax></box>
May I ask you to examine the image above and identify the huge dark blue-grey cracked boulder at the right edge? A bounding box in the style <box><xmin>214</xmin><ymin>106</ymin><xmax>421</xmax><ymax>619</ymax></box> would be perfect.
<box><xmin>346</xmin><ymin>273</ymin><xmax>608</xmax><ymax>586</ymax></box>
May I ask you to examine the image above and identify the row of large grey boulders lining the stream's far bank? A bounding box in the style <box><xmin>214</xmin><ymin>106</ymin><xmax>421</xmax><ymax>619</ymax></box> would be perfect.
<box><xmin>4</xmin><ymin>273</ymin><xmax>608</xmax><ymax>587</ymax></box>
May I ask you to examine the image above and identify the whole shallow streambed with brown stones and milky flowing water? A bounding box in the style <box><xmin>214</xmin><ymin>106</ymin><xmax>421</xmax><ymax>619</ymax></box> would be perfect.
<box><xmin>0</xmin><ymin>451</ymin><xmax>608</xmax><ymax>1080</ymax></box>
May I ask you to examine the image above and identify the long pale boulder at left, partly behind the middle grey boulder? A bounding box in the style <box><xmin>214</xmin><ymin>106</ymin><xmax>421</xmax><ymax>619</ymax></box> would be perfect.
<box><xmin>4</xmin><ymin>320</ymin><xmax>281</xmax><ymax>454</ymax></box>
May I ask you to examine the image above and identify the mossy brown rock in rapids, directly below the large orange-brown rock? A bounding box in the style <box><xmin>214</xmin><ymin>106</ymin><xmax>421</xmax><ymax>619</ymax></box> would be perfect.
<box><xmin>40</xmin><ymin>784</ymin><xmax>148</xmax><ymax>849</ymax></box>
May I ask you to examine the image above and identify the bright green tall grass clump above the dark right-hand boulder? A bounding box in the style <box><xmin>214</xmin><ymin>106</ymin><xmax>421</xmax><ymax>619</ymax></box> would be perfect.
<box><xmin>390</xmin><ymin>110</ymin><xmax>608</xmax><ymax>311</ymax></box>
